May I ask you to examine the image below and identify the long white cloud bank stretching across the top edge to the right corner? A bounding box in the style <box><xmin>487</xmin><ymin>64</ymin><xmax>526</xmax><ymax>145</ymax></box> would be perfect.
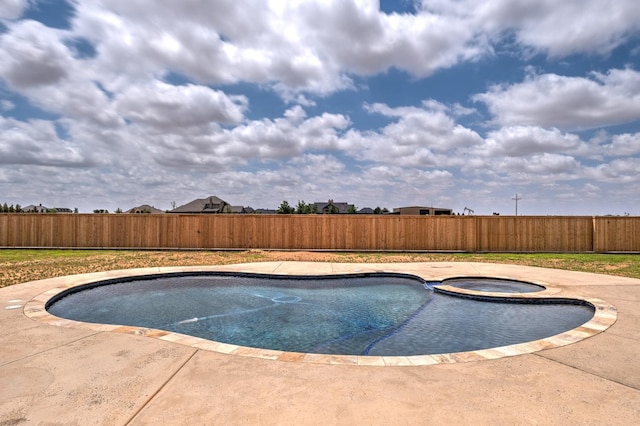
<box><xmin>56</xmin><ymin>0</ymin><xmax>638</xmax><ymax>101</ymax></box>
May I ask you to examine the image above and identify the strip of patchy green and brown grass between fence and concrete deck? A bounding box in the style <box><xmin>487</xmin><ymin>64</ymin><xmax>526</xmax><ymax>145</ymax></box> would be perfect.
<box><xmin>0</xmin><ymin>249</ymin><xmax>640</xmax><ymax>287</ymax></box>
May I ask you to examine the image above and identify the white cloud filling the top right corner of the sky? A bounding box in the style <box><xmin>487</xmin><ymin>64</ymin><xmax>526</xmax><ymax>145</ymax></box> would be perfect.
<box><xmin>422</xmin><ymin>0</ymin><xmax>640</xmax><ymax>57</ymax></box>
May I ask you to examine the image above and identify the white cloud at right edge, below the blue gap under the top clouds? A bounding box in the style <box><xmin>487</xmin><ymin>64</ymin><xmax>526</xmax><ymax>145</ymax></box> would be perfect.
<box><xmin>474</xmin><ymin>69</ymin><xmax>640</xmax><ymax>129</ymax></box>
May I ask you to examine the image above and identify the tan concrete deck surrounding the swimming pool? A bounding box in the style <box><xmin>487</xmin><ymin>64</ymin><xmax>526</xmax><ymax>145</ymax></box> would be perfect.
<box><xmin>0</xmin><ymin>262</ymin><xmax>640</xmax><ymax>425</ymax></box>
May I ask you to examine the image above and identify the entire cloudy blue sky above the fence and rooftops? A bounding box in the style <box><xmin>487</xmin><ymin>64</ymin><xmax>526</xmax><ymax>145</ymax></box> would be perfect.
<box><xmin>0</xmin><ymin>0</ymin><xmax>640</xmax><ymax>215</ymax></box>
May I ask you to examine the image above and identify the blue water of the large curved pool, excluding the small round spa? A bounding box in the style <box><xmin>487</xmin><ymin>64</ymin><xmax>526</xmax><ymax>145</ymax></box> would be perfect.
<box><xmin>47</xmin><ymin>273</ymin><xmax>594</xmax><ymax>356</ymax></box>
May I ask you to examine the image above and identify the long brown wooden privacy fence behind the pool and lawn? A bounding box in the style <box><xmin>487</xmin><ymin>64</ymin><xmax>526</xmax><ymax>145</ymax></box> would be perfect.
<box><xmin>0</xmin><ymin>213</ymin><xmax>640</xmax><ymax>252</ymax></box>
